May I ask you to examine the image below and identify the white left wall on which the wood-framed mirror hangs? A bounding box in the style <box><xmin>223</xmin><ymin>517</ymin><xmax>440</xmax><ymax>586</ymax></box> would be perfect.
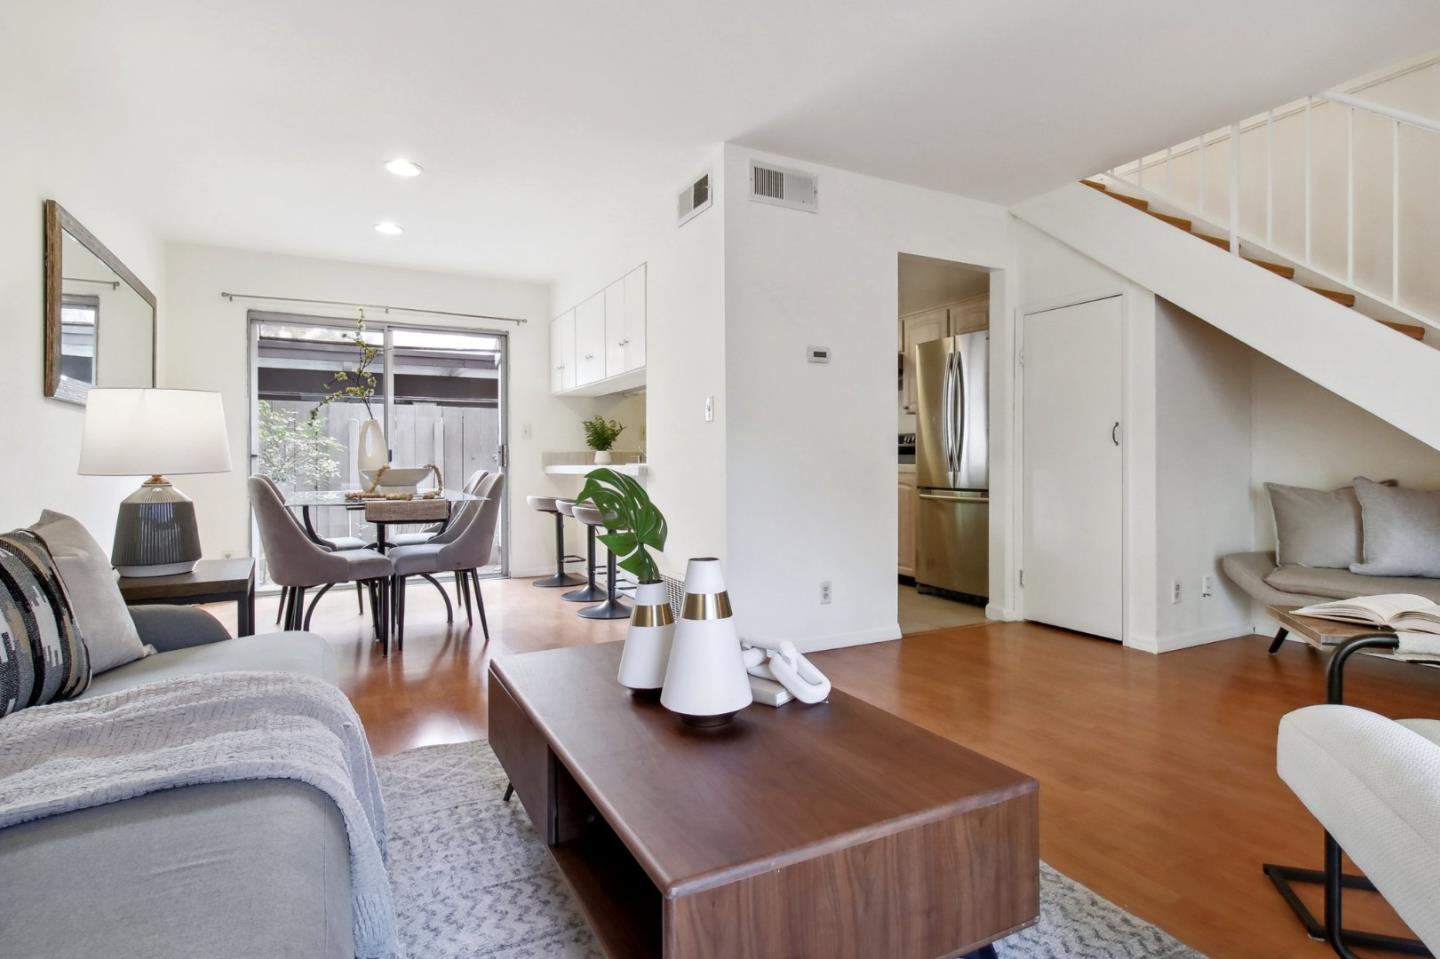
<box><xmin>0</xmin><ymin>97</ymin><xmax>166</xmax><ymax>551</ymax></box>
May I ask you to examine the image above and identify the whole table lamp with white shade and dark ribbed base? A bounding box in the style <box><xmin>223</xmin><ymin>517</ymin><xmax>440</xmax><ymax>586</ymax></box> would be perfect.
<box><xmin>79</xmin><ymin>389</ymin><xmax>230</xmax><ymax>576</ymax></box>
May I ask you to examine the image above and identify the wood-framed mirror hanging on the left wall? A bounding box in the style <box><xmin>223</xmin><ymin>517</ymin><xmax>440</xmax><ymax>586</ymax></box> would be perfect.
<box><xmin>45</xmin><ymin>200</ymin><xmax>156</xmax><ymax>403</ymax></box>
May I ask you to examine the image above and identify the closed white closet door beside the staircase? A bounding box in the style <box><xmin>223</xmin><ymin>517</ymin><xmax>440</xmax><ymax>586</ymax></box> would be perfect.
<box><xmin>1022</xmin><ymin>297</ymin><xmax>1123</xmax><ymax>639</ymax></box>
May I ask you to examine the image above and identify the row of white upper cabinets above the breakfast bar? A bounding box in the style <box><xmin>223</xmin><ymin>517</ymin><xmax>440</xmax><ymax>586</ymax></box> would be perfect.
<box><xmin>550</xmin><ymin>265</ymin><xmax>647</xmax><ymax>396</ymax></box>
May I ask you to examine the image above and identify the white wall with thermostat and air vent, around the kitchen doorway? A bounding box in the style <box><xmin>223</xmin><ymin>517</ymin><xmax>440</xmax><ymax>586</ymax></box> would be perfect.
<box><xmin>724</xmin><ymin>145</ymin><xmax>1011</xmax><ymax>648</ymax></box>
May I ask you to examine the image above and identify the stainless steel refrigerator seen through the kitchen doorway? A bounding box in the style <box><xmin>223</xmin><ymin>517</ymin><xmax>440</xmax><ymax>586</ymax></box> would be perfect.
<box><xmin>913</xmin><ymin>333</ymin><xmax>989</xmax><ymax>599</ymax></box>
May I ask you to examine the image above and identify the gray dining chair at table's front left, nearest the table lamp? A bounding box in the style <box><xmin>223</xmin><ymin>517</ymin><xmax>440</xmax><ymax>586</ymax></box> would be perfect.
<box><xmin>246</xmin><ymin>477</ymin><xmax>393</xmax><ymax>655</ymax></box>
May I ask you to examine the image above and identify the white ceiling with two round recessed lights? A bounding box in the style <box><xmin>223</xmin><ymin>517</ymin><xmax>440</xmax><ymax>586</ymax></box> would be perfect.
<box><xmin>0</xmin><ymin>0</ymin><xmax>1440</xmax><ymax>279</ymax></box>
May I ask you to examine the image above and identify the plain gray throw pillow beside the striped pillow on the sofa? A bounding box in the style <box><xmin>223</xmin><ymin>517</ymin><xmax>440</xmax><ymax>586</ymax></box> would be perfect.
<box><xmin>30</xmin><ymin>510</ymin><xmax>154</xmax><ymax>672</ymax></box>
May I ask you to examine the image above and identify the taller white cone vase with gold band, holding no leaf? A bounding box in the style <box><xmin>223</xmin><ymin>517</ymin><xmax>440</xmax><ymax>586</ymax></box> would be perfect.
<box><xmin>660</xmin><ymin>557</ymin><xmax>752</xmax><ymax>726</ymax></box>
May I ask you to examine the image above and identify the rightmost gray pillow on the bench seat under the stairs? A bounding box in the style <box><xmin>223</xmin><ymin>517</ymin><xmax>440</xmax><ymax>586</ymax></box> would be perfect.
<box><xmin>1351</xmin><ymin>477</ymin><xmax>1440</xmax><ymax>577</ymax></box>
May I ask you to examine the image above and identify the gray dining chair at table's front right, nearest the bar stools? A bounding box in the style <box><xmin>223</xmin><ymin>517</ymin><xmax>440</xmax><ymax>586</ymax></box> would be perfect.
<box><xmin>387</xmin><ymin>472</ymin><xmax>505</xmax><ymax>649</ymax></box>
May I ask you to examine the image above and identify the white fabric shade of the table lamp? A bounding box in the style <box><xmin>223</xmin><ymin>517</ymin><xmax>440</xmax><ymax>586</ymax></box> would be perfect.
<box><xmin>81</xmin><ymin>389</ymin><xmax>230</xmax><ymax>477</ymax></box>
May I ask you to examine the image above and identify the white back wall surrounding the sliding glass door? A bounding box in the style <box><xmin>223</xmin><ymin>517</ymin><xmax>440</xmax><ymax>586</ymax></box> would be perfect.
<box><xmin>161</xmin><ymin>245</ymin><xmax>578</xmax><ymax>576</ymax></box>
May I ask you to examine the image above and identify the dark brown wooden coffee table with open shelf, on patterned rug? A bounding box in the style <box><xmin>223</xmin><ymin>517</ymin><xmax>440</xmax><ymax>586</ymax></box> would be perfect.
<box><xmin>490</xmin><ymin>644</ymin><xmax>1040</xmax><ymax>959</ymax></box>
